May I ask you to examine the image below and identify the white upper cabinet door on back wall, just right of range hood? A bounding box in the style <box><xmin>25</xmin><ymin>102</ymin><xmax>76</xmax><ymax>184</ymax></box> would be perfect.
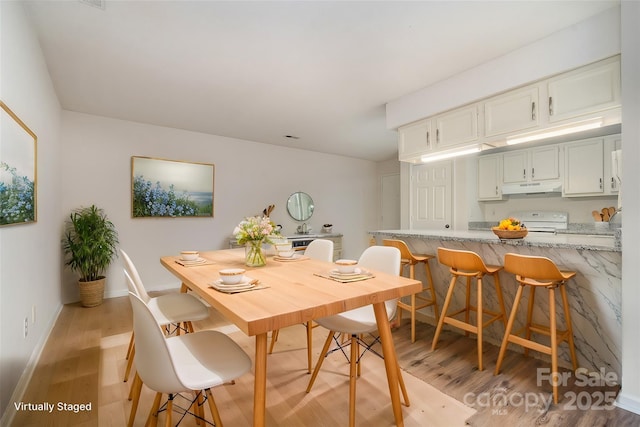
<box><xmin>562</xmin><ymin>138</ymin><xmax>605</xmax><ymax>197</ymax></box>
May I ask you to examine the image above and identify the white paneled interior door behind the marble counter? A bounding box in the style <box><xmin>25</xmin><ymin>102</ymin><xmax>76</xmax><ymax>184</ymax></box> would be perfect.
<box><xmin>411</xmin><ymin>161</ymin><xmax>453</xmax><ymax>230</ymax></box>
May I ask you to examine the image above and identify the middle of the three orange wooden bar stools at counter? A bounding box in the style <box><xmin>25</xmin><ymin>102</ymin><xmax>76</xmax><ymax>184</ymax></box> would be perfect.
<box><xmin>431</xmin><ymin>248</ymin><xmax>507</xmax><ymax>371</ymax></box>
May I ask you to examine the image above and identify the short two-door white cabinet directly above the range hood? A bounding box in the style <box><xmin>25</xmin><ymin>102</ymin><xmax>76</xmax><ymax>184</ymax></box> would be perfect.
<box><xmin>502</xmin><ymin>145</ymin><xmax>560</xmax><ymax>184</ymax></box>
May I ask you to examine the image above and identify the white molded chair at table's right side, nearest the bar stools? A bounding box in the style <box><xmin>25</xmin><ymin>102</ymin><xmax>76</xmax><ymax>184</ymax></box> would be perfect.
<box><xmin>307</xmin><ymin>246</ymin><xmax>409</xmax><ymax>426</ymax></box>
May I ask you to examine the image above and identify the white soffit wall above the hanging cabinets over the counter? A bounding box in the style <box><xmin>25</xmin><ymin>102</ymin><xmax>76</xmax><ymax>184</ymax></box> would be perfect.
<box><xmin>386</xmin><ymin>7</ymin><xmax>620</xmax><ymax>129</ymax></box>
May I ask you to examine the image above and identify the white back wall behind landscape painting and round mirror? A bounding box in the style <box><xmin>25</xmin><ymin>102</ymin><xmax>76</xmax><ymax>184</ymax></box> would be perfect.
<box><xmin>61</xmin><ymin>111</ymin><xmax>377</xmax><ymax>302</ymax></box>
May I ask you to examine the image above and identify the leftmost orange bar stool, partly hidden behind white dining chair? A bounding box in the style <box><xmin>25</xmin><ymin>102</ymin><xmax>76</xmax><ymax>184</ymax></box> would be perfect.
<box><xmin>382</xmin><ymin>239</ymin><xmax>440</xmax><ymax>343</ymax></box>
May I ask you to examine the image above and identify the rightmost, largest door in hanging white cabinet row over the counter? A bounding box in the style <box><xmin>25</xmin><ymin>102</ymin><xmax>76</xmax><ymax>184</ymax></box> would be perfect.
<box><xmin>547</xmin><ymin>57</ymin><xmax>621</xmax><ymax>123</ymax></box>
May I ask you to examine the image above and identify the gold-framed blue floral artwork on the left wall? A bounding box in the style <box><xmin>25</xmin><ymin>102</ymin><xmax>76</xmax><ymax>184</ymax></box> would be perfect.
<box><xmin>0</xmin><ymin>101</ymin><xmax>38</xmax><ymax>226</ymax></box>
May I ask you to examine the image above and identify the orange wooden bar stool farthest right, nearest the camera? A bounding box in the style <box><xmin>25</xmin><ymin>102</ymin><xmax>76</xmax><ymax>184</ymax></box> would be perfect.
<box><xmin>495</xmin><ymin>253</ymin><xmax>578</xmax><ymax>404</ymax></box>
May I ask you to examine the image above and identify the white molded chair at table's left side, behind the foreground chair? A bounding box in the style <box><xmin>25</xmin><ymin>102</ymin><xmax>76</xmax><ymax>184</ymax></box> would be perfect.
<box><xmin>120</xmin><ymin>249</ymin><xmax>209</xmax><ymax>382</ymax></box>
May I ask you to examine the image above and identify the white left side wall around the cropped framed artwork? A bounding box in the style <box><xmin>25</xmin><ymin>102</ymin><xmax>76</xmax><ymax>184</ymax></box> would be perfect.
<box><xmin>0</xmin><ymin>1</ymin><xmax>62</xmax><ymax>425</ymax></box>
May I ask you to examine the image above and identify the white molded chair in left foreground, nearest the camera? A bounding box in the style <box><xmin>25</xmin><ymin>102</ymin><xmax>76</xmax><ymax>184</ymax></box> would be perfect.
<box><xmin>129</xmin><ymin>292</ymin><xmax>251</xmax><ymax>427</ymax></box>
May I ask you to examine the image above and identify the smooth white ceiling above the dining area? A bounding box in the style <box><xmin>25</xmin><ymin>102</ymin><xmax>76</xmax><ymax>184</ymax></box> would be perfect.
<box><xmin>23</xmin><ymin>0</ymin><xmax>618</xmax><ymax>161</ymax></box>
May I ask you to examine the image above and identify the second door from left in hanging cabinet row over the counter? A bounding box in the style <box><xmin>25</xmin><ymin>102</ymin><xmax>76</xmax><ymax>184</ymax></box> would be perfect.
<box><xmin>433</xmin><ymin>104</ymin><xmax>479</xmax><ymax>150</ymax></box>
